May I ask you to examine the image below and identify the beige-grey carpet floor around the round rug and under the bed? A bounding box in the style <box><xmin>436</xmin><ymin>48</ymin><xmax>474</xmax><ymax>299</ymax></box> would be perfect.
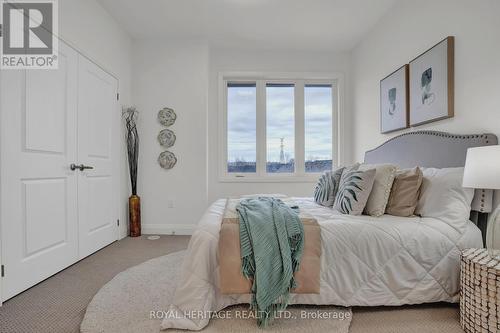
<box><xmin>0</xmin><ymin>236</ymin><xmax>462</xmax><ymax>333</ymax></box>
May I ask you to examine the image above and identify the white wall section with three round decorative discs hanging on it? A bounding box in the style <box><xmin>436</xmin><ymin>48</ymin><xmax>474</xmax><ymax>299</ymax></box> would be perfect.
<box><xmin>132</xmin><ymin>40</ymin><xmax>208</xmax><ymax>234</ymax></box>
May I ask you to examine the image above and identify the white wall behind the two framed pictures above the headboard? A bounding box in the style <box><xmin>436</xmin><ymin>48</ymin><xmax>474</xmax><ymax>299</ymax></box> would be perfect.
<box><xmin>351</xmin><ymin>0</ymin><xmax>500</xmax><ymax>161</ymax></box>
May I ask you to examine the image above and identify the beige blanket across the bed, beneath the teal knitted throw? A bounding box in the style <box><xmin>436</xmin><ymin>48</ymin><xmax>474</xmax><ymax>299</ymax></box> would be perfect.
<box><xmin>218</xmin><ymin>198</ymin><xmax>321</xmax><ymax>294</ymax></box>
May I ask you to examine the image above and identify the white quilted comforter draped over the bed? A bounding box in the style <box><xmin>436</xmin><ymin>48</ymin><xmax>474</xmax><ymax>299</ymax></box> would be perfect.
<box><xmin>162</xmin><ymin>198</ymin><xmax>482</xmax><ymax>330</ymax></box>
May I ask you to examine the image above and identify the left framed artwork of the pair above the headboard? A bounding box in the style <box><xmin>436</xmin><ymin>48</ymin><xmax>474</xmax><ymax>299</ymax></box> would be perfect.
<box><xmin>380</xmin><ymin>65</ymin><xmax>409</xmax><ymax>133</ymax></box>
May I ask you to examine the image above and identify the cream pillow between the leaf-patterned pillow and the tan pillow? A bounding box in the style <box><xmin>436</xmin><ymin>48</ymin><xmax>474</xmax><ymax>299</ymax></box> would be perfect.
<box><xmin>359</xmin><ymin>164</ymin><xmax>397</xmax><ymax>216</ymax></box>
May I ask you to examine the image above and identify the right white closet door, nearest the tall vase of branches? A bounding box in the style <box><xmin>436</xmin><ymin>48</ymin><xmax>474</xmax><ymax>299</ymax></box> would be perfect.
<box><xmin>78</xmin><ymin>56</ymin><xmax>121</xmax><ymax>258</ymax></box>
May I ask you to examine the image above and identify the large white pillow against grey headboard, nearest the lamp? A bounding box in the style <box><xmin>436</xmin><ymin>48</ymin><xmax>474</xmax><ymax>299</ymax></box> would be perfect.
<box><xmin>415</xmin><ymin>168</ymin><xmax>474</xmax><ymax>227</ymax></box>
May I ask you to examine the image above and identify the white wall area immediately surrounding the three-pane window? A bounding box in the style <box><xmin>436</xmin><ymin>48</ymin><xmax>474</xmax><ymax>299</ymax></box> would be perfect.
<box><xmin>208</xmin><ymin>45</ymin><xmax>351</xmax><ymax>203</ymax></box>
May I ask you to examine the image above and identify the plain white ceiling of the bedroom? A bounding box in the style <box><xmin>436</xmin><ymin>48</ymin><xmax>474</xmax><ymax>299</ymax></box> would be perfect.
<box><xmin>98</xmin><ymin>0</ymin><xmax>397</xmax><ymax>51</ymax></box>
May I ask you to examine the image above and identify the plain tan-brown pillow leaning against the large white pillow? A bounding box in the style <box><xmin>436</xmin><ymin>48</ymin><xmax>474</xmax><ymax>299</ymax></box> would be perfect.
<box><xmin>385</xmin><ymin>167</ymin><xmax>423</xmax><ymax>217</ymax></box>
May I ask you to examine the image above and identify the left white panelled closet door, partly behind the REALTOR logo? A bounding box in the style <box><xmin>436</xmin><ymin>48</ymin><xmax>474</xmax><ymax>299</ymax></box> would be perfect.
<box><xmin>0</xmin><ymin>42</ymin><xmax>78</xmax><ymax>300</ymax></box>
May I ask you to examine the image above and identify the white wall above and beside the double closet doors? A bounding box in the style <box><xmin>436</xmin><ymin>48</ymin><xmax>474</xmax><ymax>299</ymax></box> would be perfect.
<box><xmin>59</xmin><ymin>0</ymin><xmax>132</xmax><ymax>237</ymax></box>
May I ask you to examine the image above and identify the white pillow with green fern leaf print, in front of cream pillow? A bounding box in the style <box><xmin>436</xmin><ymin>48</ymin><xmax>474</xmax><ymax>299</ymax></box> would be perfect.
<box><xmin>333</xmin><ymin>167</ymin><xmax>375</xmax><ymax>215</ymax></box>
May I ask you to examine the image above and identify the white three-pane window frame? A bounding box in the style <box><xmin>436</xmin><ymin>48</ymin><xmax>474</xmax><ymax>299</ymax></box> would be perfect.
<box><xmin>218</xmin><ymin>72</ymin><xmax>344</xmax><ymax>183</ymax></box>
